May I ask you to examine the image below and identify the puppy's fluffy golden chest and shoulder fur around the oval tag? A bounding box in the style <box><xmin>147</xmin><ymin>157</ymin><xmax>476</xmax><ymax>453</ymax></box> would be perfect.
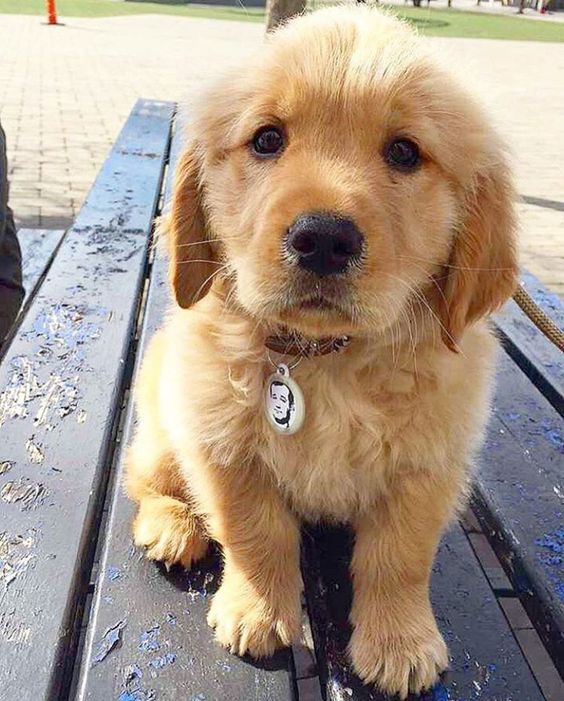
<box><xmin>161</xmin><ymin>300</ymin><xmax>494</xmax><ymax>521</ymax></box>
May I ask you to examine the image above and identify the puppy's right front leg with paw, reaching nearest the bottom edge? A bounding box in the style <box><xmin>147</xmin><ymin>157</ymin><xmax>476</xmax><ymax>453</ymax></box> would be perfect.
<box><xmin>349</xmin><ymin>471</ymin><xmax>461</xmax><ymax>698</ymax></box>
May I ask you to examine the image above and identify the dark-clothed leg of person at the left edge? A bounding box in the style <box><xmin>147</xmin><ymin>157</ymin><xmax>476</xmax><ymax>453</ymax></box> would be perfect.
<box><xmin>0</xmin><ymin>125</ymin><xmax>24</xmax><ymax>348</ymax></box>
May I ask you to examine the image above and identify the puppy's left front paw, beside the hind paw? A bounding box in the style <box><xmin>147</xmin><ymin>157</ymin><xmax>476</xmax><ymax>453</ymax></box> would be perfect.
<box><xmin>208</xmin><ymin>580</ymin><xmax>300</xmax><ymax>658</ymax></box>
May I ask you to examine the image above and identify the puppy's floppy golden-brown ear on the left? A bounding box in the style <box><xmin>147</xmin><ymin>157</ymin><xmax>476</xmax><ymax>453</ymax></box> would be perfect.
<box><xmin>165</xmin><ymin>144</ymin><xmax>217</xmax><ymax>309</ymax></box>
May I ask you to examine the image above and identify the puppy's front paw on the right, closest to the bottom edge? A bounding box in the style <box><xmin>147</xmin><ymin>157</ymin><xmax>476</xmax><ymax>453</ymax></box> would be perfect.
<box><xmin>349</xmin><ymin>620</ymin><xmax>448</xmax><ymax>699</ymax></box>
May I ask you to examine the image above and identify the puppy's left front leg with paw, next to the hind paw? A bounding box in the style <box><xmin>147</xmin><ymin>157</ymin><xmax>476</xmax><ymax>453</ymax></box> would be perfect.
<box><xmin>198</xmin><ymin>466</ymin><xmax>301</xmax><ymax>657</ymax></box>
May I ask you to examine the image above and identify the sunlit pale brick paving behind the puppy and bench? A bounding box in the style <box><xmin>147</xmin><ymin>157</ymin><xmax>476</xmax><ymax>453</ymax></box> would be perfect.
<box><xmin>0</xmin><ymin>15</ymin><xmax>564</xmax><ymax>294</ymax></box>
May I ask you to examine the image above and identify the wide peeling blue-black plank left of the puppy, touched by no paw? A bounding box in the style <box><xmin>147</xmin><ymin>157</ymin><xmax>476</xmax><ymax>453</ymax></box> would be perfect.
<box><xmin>0</xmin><ymin>101</ymin><xmax>172</xmax><ymax>699</ymax></box>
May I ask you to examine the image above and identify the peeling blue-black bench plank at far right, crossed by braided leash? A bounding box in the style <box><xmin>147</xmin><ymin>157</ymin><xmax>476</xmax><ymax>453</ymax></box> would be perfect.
<box><xmin>495</xmin><ymin>271</ymin><xmax>564</xmax><ymax>416</ymax></box>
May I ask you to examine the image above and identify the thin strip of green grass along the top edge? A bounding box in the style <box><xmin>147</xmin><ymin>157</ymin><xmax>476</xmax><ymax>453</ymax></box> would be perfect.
<box><xmin>0</xmin><ymin>0</ymin><xmax>564</xmax><ymax>42</ymax></box>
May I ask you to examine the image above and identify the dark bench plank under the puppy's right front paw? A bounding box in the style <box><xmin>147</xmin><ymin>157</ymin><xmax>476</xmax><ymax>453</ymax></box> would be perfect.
<box><xmin>302</xmin><ymin>525</ymin><xmax>543</xmax><ymax>701</ymax></box>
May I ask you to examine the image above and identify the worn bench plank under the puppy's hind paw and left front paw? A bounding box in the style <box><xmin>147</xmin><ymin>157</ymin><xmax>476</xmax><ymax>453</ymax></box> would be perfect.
<box><xmin>78</xmin><ymin>112</ymin><xmax>294</xmax><ymax>701</ymax></box>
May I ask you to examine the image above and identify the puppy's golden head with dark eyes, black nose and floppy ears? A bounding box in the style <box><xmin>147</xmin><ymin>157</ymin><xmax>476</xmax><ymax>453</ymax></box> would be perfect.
<box><xmin>169</xmin><ymin>8</ymin><xmax>516</xmax><ymax>347</ymax></box>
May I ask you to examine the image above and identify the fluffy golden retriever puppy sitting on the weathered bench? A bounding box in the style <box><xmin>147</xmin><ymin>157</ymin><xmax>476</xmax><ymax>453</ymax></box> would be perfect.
<box><xmin>126</xmin><ymin>8</ymin><xmax>517</xmax><ymax>697</ymax></box>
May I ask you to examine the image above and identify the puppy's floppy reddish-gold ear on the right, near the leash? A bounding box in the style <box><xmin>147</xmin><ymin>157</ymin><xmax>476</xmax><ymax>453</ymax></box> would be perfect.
<box><xmin>441</xmin><ymin>163</ymin><xmax>518</xmax><ymax>351</ymax></box>
